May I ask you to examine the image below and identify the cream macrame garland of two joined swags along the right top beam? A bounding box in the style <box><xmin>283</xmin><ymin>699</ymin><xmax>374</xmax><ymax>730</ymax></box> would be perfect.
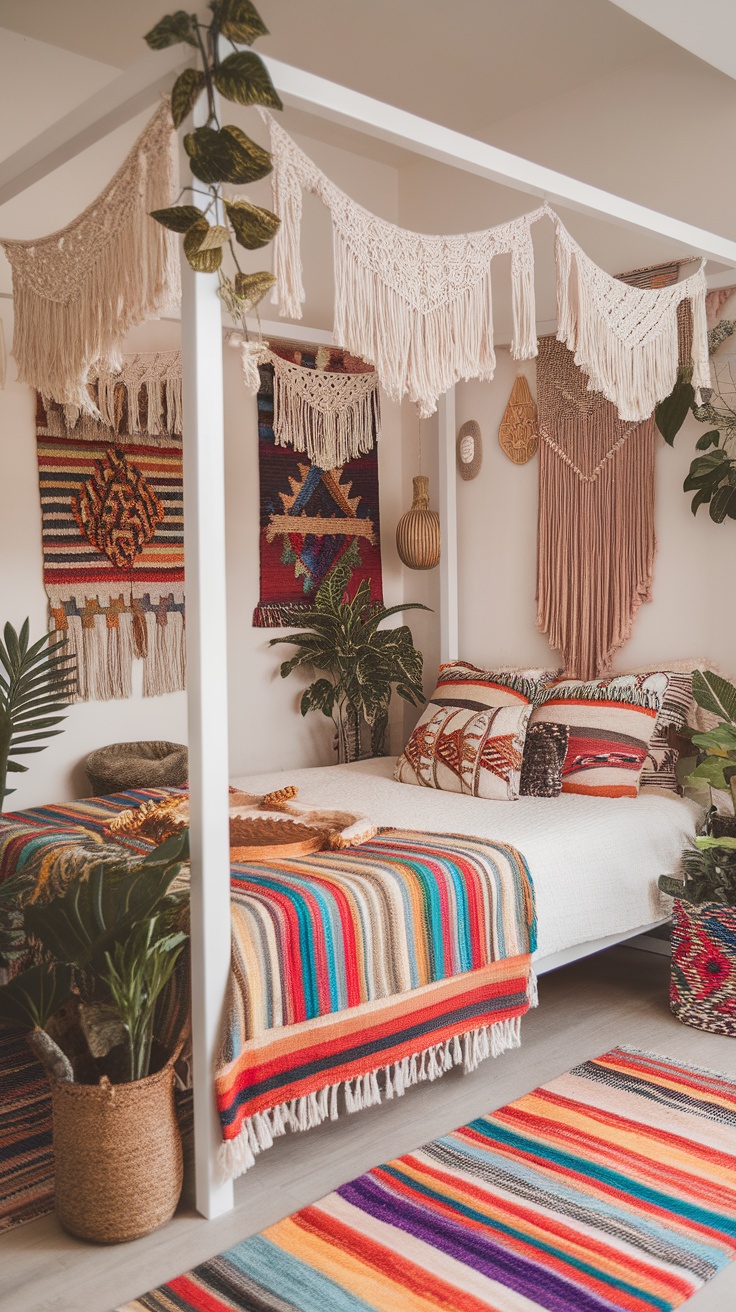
<box><xmin>260</xmin><ymin>110</ymin><xmax>710</xmax><ymax>422</ymax></box>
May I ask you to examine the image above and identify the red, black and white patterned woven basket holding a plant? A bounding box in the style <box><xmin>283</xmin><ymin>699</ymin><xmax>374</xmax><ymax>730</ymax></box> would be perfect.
<box><xmin>669</xmin><ymin>897</ymin><xmax>736</xmax><ymax>1038</ymax></box>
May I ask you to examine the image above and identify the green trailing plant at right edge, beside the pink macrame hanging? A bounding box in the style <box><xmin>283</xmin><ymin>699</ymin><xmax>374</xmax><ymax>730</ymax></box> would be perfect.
<box><xmin>655</xmin><ymin>319</ymin><xmax>736</xmax><ymax>523</ymax></box>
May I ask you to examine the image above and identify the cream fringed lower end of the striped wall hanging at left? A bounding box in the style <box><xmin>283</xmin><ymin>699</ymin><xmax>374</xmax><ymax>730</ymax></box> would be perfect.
<box><xmin>50</xmin><ymin>610</ymin><xmax>186</xmax><ymax>702</ymax></box>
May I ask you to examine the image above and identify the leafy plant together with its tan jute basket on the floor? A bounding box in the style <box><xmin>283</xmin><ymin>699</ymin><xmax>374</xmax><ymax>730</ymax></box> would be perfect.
<box><xmin>0</xmin><ymin>833</ymin><xmax>188</xmax><ymax>1242</ymax></box>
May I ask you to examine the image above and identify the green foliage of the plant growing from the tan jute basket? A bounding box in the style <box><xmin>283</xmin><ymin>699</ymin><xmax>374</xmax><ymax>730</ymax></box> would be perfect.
<box><xmin>0</xmin><ymin>832</ymin><xmax>189</xmax><ymax>1081</ymax></box>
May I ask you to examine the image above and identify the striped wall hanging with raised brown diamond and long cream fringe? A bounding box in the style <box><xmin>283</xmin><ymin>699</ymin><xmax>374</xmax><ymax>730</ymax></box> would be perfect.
<box><xmin>37</xmin><ymin>400</ymin><xmax>186</xmax><ymax>701</ymax></box>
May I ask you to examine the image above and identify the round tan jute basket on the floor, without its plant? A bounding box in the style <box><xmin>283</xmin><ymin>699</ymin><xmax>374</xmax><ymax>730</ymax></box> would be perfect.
<box><xmin>51</xmin><ymin>1061</ymin><xmax>182</xmax><ymax>1244</ymax></box>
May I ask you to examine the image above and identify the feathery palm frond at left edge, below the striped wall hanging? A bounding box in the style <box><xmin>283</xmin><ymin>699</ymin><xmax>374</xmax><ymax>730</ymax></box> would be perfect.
<box><xmin>0</xmin><ymin>619</ymin><xmax>76</xmax><ymax>812</ymax></box>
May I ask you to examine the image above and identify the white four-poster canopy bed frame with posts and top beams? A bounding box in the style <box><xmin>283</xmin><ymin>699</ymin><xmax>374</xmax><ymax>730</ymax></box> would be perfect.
<box><xmin>0</xmin><ymin>38</ymin><xmax>736</xmax><ymax>1218</ymax></box>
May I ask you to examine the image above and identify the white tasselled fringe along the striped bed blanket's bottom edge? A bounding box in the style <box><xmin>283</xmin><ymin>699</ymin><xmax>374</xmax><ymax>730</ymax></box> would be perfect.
<box><xmin>218</xmin><ymin>1007</ymin><xmax>524</xmax><ymax>1179</ymax></box>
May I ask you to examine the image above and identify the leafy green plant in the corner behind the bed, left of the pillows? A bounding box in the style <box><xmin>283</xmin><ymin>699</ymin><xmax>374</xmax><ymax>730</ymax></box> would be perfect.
<box><xmin>270</xmin><ymin>560</ymin><xmax>429</xmax><ymax>761</ymax></box>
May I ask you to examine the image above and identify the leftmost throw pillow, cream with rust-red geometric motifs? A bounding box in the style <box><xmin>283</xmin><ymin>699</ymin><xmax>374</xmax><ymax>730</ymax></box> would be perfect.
<box><xmin>394</xmin><ymin>661</ymin><xmax>538</xmax><ymax>802</ymax></box>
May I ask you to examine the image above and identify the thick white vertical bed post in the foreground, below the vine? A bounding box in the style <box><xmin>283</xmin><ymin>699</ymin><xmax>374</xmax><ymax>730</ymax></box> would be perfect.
<box><xmin>181</xmin><ymin>112</ymin><xmax>234</xmax><ymax>1219</ymax></box>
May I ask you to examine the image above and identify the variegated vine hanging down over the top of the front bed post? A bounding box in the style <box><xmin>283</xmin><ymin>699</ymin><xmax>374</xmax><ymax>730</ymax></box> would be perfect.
<box><xmin>146</xmin><ymin>0</ymin><xmax>283</xmax><ymax>328</ymax></box>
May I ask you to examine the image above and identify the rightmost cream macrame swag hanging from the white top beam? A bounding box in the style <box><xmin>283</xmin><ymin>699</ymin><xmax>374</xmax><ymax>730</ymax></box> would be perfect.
<box><xmin>555</xmin><ymin>215</ymin><xmax>711</xmax><ymax>424</ymax></box>
